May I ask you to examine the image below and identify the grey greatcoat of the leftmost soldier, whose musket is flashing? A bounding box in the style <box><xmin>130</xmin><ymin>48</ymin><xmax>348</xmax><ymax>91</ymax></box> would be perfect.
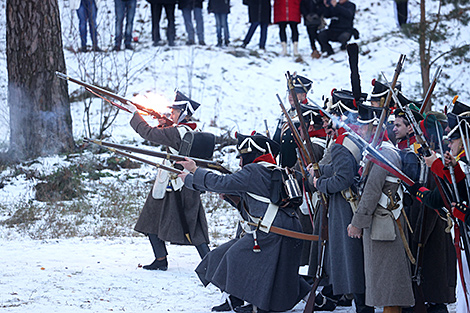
<box><xmin>131</xmin><ymin>114</ymin><xmax>209</xmax><ymax>246</ymax></box>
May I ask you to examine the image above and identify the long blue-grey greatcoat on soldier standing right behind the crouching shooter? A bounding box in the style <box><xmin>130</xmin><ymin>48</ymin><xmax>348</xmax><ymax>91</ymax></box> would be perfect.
<box><xmin>312</xmin><ymin>144</ymin><xmax>365</xmax><ymax>295</ymax></box>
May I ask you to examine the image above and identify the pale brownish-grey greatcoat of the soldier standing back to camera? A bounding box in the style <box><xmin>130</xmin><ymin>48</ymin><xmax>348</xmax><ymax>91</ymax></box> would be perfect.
<box><xmin>351</xmin><ymin>142</ymin><xmax>415</xmax><ymax>307</ymax></box>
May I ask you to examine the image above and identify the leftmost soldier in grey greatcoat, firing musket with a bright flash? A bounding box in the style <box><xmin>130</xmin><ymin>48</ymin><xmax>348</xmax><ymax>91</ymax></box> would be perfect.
<box><xmin>123</xmin><ymin>91</ymin><xmax>209</xmax><ymax>271</ymax></box>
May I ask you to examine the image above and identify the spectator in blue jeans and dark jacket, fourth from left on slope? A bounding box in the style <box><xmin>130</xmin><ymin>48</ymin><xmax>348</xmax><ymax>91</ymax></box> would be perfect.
<box><xmin>178</xmin><ymin>0</ymin><xmax>206</xmax><ymax>46</ymax></box>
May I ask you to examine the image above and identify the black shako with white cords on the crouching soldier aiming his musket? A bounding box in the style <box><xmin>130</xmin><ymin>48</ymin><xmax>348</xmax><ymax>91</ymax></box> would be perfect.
<box><xmin>235</xmin><ymin>132</ymin><xmax>280</xmax><ymax>158</ymax></box>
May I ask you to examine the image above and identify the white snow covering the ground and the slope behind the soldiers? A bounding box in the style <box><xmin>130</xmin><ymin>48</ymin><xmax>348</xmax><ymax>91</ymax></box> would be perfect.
<box><xmin>0</xmin><ymin>0</ymin><xmax>470</xmax><ymax>313</ymax></box>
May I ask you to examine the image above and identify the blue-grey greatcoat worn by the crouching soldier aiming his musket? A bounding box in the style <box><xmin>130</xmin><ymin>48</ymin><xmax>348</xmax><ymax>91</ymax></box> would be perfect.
<box><xmin>185</xmin><ymin>163</ymin><xmax>310</xmax><ymax>311</ymax></box>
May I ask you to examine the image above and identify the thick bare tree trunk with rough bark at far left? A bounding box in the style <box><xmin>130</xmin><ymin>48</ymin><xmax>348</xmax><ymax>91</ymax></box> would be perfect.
<box><xmin>6</xmin><ymin>0</ymin><xmax>75</xmax><ymax>160</ymax></box>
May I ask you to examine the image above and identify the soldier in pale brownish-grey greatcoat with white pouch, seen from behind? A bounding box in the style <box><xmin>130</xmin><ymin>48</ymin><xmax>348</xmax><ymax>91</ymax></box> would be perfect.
<box><xmin>347</xmin><ymin>105</ymin><xmax>415</xmax><ymax>313</ymax></box>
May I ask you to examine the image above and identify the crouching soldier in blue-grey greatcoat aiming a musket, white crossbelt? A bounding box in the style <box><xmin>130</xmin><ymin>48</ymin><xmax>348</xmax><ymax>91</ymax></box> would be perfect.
<box><xmin>178</xmin><ymin>134</ymin><xmax>310</xmax><ymax>313</ymax></box>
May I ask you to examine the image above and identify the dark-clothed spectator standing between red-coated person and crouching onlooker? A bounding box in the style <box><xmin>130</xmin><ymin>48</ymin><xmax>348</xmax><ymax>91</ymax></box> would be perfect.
<box><xmin>300</xmin><ymin>0</ymin><xmax>325</xmax><ymax>59</ymax></box>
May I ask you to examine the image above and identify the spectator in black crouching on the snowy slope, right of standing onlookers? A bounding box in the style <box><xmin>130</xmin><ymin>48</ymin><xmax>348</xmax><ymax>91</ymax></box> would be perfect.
<box><xmin>318</xmin><ymin>0</ymin><xmax>359</xmax><ymax>56</ymax></box>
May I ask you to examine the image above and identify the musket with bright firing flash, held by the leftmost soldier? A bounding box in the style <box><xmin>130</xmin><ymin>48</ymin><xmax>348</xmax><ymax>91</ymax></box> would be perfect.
<box><xmin>55</xmin><ymin>72</ymin><xmax>173</xmax><ymax>126</ymax></box>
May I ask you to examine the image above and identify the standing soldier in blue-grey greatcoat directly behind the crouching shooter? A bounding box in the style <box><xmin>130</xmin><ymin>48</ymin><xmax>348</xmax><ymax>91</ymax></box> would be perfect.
<box><xmin>308</xmin><ymin>91</ymin><xmax>374</xmax><ymax>313</ymax></box>
